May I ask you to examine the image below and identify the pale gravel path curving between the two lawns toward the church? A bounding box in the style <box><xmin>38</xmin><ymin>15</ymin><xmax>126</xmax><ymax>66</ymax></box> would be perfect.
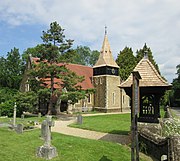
<box><xmin>51</xmin><ymin>115</ymin><xmax>130</xmax><ymax>144</ymax></box>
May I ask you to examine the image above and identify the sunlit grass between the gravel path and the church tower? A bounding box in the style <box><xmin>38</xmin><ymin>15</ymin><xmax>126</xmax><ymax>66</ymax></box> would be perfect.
<box><xmin>70</xmin><ymin>113</ymin><xmax>131</xmax><ymax>135</ymax></box>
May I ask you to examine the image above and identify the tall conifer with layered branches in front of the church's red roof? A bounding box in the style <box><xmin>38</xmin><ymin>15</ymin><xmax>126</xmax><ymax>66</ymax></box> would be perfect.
<box><xmin>30</xmin><ymin>22</ymin><xmax>90</xmax><ymax>114</ymax></box>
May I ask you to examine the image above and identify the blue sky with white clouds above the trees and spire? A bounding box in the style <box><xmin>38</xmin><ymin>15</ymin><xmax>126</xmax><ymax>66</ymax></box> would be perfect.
<box><xmin>0</xmin><ymin>0</ymin><xmax>180</xmax><ymax>83</ymax></box>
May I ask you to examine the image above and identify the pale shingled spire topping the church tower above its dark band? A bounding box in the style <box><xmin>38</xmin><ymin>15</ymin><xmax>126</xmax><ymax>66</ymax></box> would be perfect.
<box><xmin>93</xmin><ymin>26</ymin><xmax>119</xmax><ymax>68</ymax></box>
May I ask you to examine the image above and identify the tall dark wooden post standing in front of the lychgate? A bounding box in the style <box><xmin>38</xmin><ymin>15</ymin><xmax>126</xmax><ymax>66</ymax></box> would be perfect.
<box><xmin>131</xmin><ymin>71</ymin><xmax>141</xmax><ymax>161</ymax></box>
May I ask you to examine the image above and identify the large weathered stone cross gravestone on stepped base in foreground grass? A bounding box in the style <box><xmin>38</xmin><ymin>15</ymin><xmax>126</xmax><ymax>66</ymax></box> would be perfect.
<box><xmin>36</xmin><ymin>116</ymin><xmax>58</xmax><ymax>159</ymax></box>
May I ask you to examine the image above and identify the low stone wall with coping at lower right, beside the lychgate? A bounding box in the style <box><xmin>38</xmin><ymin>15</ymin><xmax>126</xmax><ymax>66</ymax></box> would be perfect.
<box><xmin>139</xmin><ymin>124</ymin><xmax>180</xmax><ymax>161</ymax></box>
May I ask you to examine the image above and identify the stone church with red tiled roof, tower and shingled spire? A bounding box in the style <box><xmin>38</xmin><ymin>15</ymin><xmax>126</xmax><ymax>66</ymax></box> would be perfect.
<box><xmin>20</xmin><ymin>32</ymin><xmax>130</xmax><ymax>114</ymax></box>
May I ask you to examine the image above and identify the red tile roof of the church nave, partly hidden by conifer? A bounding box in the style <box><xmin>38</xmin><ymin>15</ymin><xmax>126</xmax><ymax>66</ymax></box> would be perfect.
<box><xmin>31</xmin><ymin>57</ymin><xmax>94</xmax><ymax>90</ymax></box>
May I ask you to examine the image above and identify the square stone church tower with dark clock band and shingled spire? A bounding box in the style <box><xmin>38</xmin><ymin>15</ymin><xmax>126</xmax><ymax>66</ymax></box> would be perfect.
<box><xmin>93</xmin><ymin>30</ymin><xmax>121</xmax><ymax>112</ymax></box>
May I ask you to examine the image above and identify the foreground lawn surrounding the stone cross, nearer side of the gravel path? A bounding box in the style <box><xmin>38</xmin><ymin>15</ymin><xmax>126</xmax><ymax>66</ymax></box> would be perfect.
<box><xmin>0</xmin><ymin>128</ymin><xmax>150</xmax><ymax>161</ymax></box>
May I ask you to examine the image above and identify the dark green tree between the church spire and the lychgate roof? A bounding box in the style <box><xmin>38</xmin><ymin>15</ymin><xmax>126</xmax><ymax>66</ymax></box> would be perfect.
<box><xmin>116</xmin><ymin>47</ymin><xmax>136</xmax><ymax>80</ymax></box>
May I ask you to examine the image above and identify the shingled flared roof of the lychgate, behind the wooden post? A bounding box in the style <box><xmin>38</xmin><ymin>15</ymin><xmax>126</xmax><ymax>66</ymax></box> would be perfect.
<box><xmin>120</xmin><ymin>58</ymin><xmax>171</xmax><ymax>88</ymax></box>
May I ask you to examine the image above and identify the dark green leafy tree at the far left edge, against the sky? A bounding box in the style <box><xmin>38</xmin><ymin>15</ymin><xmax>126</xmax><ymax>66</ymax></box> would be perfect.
<box><xmin>0</xmin><ymin>48</ymin><xmax>25</xmax><ymax>89</ymax></box>
